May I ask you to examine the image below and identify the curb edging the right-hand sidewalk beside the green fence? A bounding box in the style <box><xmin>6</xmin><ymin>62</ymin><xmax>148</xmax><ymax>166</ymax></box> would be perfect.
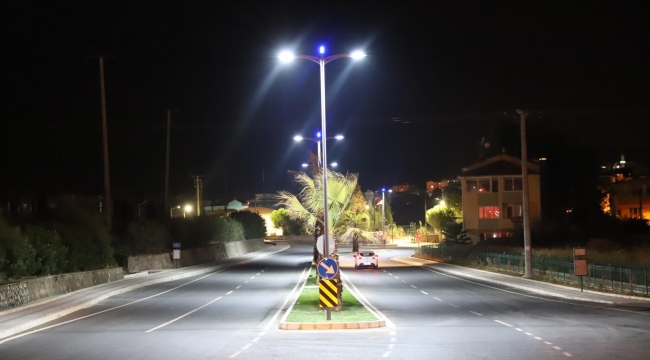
<box><xmin>392</xmin><ymin>257</ymin><xmax>650</xmax><ymax>305</ymax></box>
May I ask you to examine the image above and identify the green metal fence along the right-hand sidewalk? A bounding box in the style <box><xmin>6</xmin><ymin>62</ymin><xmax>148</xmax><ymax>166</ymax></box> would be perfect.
<box><xmin>418</xmin><ymin>245</ymin><xmax>650</xmax><ymax>295</ymax></box>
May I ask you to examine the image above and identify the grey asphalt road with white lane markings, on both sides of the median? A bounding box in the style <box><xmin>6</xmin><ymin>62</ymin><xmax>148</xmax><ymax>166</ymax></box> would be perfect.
<box><xmin>0</xmin><ymin>245</ymin><xmax>650</xmax><ymax>360</ymax></box>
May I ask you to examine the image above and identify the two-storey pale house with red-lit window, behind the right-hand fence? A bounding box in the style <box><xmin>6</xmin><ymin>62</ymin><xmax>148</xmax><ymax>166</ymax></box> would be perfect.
<box><xmin>458</xmin><ymin>154</ymin><xmax>541</xmax><ymax>242</ymax></box>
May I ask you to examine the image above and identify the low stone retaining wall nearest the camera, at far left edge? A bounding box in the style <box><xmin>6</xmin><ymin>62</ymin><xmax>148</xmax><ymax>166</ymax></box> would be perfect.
<box><xmin>0</xmin><ymin>268</ymin><xmax>124</xmax><ymax>310</ymax></box>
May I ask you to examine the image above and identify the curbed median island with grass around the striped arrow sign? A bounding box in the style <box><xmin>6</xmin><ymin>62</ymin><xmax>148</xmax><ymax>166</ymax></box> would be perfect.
<box><xmin>280</xmin><ymin>266</ymin><xmax>386</xmax><ymax>330</ymax></box>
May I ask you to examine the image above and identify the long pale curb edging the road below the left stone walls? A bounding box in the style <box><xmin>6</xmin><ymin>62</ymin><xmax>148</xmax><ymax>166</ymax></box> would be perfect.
<box><xmin>0</xmin><ymin>245</ymin><xmax>290</xmax><ymax>339</ymax></box>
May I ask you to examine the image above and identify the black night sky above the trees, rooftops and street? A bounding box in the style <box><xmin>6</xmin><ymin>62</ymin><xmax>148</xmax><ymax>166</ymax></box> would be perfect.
<box><xmin>0</xmin><ymin>1</ymin><xmax>650</xmax><ymax>199</ymax></box>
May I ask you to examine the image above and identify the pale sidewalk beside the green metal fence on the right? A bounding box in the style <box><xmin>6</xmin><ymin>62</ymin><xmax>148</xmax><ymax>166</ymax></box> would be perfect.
<box><xmin>392</xmin><ymin>256</ymin><xmax>650</xmax><ymax>305</ymax></box>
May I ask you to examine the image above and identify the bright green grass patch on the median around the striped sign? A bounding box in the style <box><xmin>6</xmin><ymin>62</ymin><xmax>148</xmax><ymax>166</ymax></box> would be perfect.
<box><xmin>285</xmin><ymin>284</ymin><xmax>378</xmax><ymax>323</ymax></box>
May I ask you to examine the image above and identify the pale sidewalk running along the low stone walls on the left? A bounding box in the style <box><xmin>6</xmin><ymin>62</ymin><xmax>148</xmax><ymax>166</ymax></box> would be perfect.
<box><xmin>0</xmin><ymin>244</ymin><xmax>290</xmax><ymax>339</ymax></box>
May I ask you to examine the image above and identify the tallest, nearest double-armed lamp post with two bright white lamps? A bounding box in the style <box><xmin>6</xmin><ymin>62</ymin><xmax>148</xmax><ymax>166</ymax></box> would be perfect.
<box><xmin>279</xmin><ymin>46</ymin><xmax>366</xmax><ymax>257</ymax></box>
